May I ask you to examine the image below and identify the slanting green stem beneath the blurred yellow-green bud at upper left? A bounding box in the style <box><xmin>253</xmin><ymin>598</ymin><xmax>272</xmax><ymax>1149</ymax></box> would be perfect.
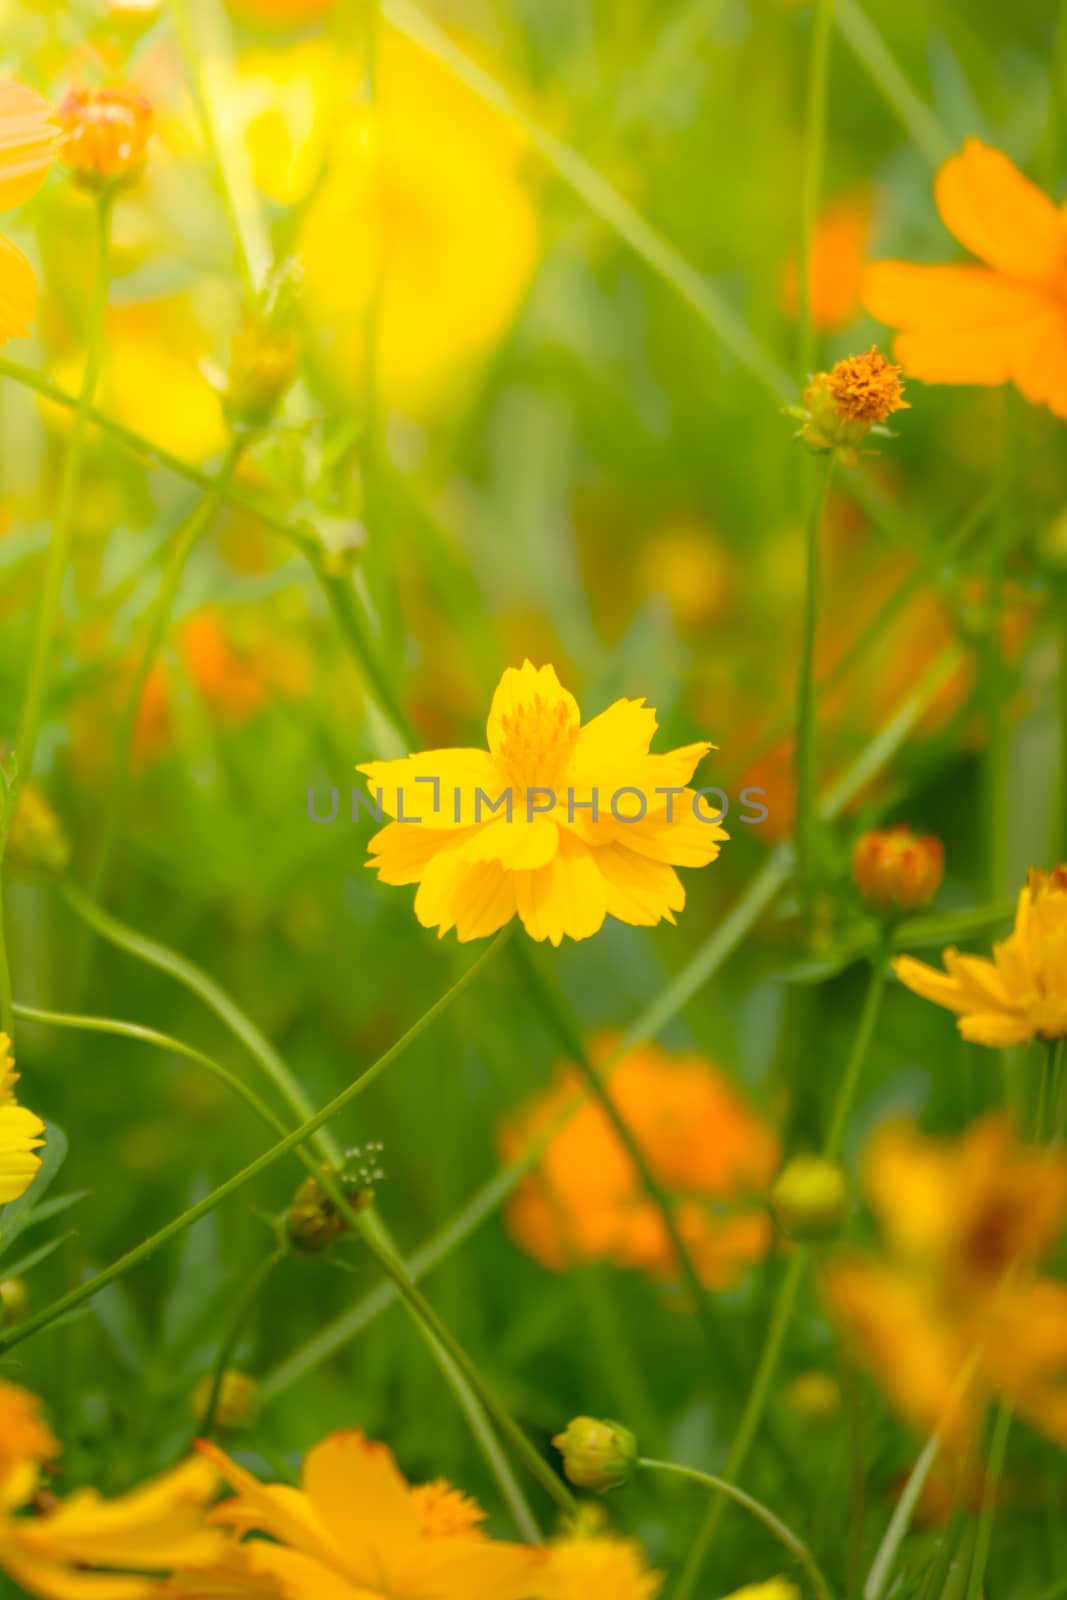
<box><xmin>75</xmin><ymin>437</ymin><xmax>246</xmax><ymax>934</ymax></box>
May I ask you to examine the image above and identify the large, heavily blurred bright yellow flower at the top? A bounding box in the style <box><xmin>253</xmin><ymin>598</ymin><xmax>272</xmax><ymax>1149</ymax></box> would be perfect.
<box><xmin>242</xmin><ymin>32</ymin><xmax>539</xmax><ymax>414</ymax></box>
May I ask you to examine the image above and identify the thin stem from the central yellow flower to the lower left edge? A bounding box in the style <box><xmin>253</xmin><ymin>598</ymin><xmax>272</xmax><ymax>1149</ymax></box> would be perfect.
<box><xmin>0</xmin><ymin>936</ymin><xmax>502</xmax><ymax>1350</ymax></box>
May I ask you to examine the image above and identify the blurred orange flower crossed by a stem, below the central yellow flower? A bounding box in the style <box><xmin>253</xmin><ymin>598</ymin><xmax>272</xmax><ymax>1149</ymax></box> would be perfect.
<box><xmin>501</xmin><ymin>1034</ymin><xmax>779</xmax><ymax>1288</ymax></box>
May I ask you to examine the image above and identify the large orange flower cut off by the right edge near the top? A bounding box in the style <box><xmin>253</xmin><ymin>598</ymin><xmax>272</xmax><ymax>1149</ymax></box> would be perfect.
<box><xmin>864</xmin><ymin>139</ymin><xmax>1067</xmax><ymax>418</ymax></box>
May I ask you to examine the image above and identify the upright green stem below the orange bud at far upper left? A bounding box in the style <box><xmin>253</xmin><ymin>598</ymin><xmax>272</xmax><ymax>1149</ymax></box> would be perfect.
<box><xmin>11</xmin><ymin>190</ymin><xmax>114</xmax><ymax>796</ymax></box>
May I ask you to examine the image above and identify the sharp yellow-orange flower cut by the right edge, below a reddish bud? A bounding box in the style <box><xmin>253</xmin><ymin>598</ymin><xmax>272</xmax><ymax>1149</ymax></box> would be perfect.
<box><xmin>893</xmin><ymin>867</ymin><xmax>1067</xmax><ymax>1048</ymax></box>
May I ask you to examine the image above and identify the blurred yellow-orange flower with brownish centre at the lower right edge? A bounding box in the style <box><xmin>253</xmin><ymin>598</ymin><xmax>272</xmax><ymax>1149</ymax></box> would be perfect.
<box><xmin>824</xmin><ymin>1112</ymin><xmax>1067</xmax><ymax>1453</ymax></box>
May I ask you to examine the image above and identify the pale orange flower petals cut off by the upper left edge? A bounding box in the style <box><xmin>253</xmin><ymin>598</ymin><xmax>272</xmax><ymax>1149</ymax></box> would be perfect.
<box><xmin>0</xmin><ymin>78</ymin><xmax>61</xmax><ymax>344</ymax></box>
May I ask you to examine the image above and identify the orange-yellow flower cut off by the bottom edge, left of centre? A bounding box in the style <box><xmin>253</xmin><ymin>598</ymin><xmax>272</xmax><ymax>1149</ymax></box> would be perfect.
<box><xmin>195</xmin><ymin>1432</ymin><xmax>537</xmax><ymax>1600</ymax></box>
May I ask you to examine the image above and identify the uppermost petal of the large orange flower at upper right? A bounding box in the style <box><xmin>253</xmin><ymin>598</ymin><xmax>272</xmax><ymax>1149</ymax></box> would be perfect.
<box><xmin>934</xmin><ymin>139</ymin><xmax>1067</xmax><ymax>283</ymax></box>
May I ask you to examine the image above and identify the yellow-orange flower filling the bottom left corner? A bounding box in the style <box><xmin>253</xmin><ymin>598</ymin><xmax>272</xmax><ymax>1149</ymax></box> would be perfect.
<box><xmin>0</xmin><ymin>1384</ymin><xmax>226</xmax><ymax>1600</ymax></box>
